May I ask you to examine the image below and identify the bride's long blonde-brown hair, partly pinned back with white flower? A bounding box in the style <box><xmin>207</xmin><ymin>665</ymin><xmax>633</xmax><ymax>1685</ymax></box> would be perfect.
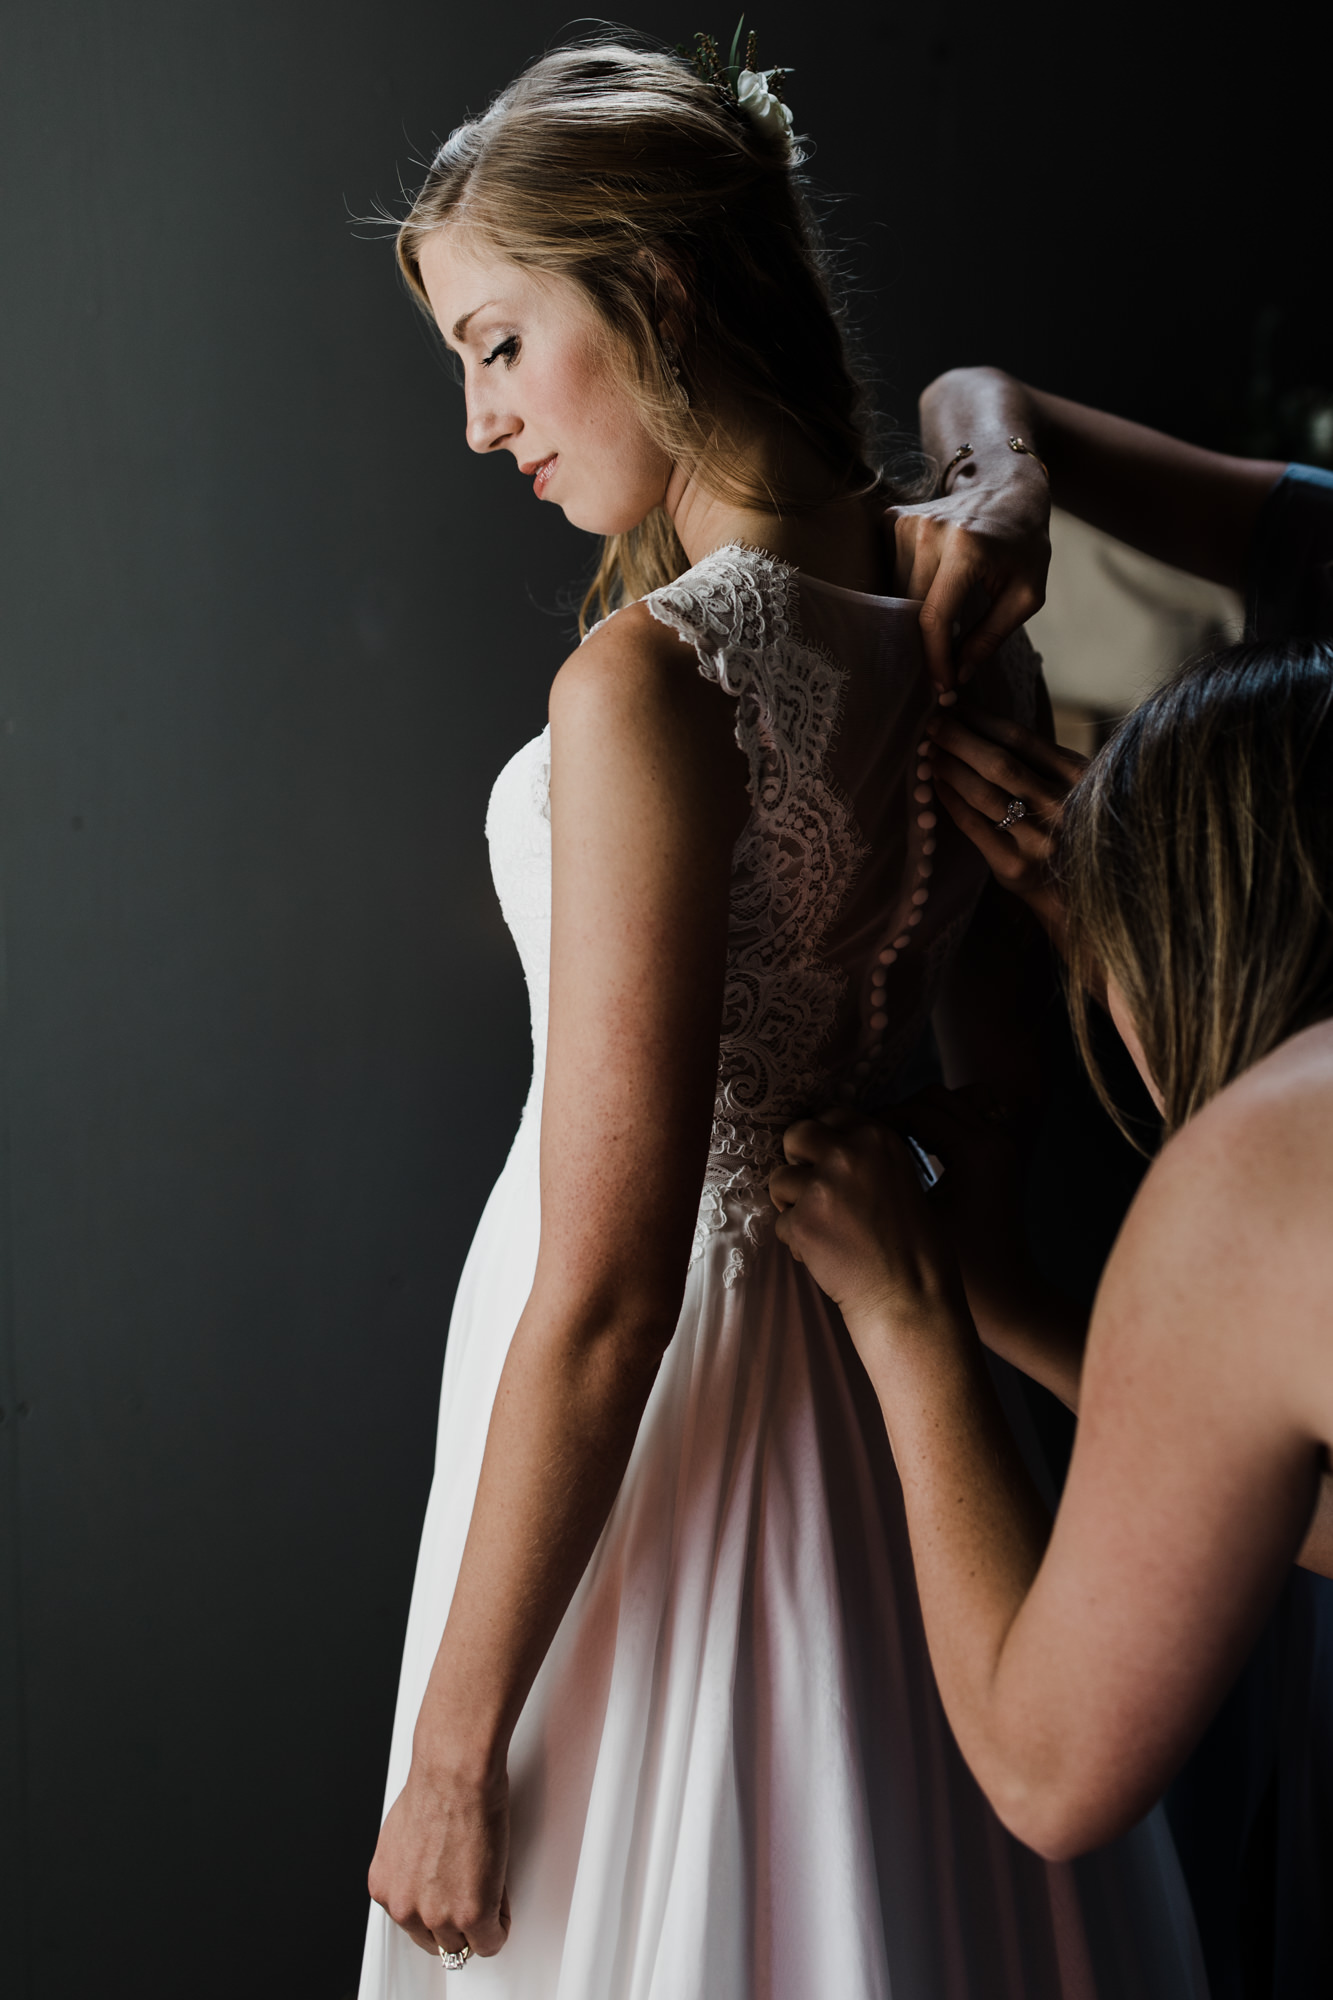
<box><xmin>398</xmin><ymin>42</ymin><xmax>891</xmax><ymax>612</ymax></box>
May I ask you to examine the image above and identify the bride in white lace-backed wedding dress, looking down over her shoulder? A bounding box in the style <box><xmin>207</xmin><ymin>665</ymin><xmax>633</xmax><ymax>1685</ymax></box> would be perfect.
<box><xmin>360</xmin><ymin>42</ymin><xmax>1203</xmax><ymax>2000</ymax></box>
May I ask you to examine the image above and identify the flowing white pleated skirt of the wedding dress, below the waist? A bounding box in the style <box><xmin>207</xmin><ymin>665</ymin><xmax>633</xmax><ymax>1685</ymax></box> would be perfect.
<box><xmin>360</xmin><ymin>1112</ymin><xmax>1207</xmax><ymax>2000</ymax></box>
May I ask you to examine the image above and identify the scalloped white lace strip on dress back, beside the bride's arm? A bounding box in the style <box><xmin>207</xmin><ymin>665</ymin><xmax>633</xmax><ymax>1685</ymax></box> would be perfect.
<box><xmin>646</xmin><ymin>548</ymin><xmax>861</xmax><ymax>1256</ymax></box>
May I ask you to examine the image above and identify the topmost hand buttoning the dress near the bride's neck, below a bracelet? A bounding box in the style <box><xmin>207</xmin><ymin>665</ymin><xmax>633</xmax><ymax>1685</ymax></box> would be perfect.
<box><xmin>880</xmin><ymin>460</ymin><xmax>1051</xmax><ymax>690</ymax></box>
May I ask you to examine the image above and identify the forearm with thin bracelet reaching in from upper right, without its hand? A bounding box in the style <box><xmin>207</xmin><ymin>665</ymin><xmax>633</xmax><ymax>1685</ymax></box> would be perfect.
<box><xmin>921</xmin><ymin>368</ymin><xmax>1285</xmax><ymax>592</ymax></box>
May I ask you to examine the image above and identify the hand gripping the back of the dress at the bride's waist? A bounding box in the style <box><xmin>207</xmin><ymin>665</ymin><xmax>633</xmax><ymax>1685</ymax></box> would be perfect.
<box><xmin>769</xmin><ymin>1118</ymin><xmax>967</xmax><ymax>1360</ymax></box>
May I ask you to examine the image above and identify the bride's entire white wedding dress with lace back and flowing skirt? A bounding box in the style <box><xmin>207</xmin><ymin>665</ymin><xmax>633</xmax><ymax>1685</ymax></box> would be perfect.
<box><xmin>360</xmin><ymin>548</ymin><xmax>1205</xmax><ymax>2000</ymax></box>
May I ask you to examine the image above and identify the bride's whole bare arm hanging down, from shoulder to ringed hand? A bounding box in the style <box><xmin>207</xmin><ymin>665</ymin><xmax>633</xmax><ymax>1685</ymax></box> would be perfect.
<box><xmin>370</xmin><ymin>606</ymin><xmax>749</xmax><ymax>1954</ymax></box>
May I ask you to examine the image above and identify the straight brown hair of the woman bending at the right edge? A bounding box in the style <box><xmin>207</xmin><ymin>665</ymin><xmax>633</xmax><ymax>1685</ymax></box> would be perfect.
<box><xmin>1061</xmin><ymin>640</ymin><xmax>1333</xmax><ymax>1132</ymax></box>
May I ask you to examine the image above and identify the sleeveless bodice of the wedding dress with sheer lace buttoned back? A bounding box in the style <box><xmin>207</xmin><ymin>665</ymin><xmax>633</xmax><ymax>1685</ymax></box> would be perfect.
<box><xmin>486</xmin><ymin>546</ymin><xmax>1039</xmax><ymax>1248</ymax></box>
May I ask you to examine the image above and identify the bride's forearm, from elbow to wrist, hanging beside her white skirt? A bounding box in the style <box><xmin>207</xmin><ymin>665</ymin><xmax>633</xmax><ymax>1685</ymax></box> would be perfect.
<box><xmin>414</xmin><ymin>1292</ymin><xmax>673</xmax><ymax>1780</ymax></box>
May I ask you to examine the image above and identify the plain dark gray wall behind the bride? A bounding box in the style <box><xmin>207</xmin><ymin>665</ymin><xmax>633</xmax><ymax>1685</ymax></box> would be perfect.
<box><xmin>0</xmin><ymin>0</ymin><xmax>1327</xmax><ymax>2000</ymax></box>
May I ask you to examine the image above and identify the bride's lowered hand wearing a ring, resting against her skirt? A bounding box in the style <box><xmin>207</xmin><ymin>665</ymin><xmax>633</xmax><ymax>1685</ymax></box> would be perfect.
<box><xmin>370</xmin><ymin>1758</ymin><xmax>508</xmax><ymax>1958</ymax></box>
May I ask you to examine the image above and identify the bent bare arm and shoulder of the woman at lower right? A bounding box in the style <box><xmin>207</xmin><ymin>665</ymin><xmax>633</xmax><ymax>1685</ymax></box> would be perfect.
<box><xmin>773</xmin><ymin>1048</ymin><xmax>1333</xmax><ymax>1858</ymax></box>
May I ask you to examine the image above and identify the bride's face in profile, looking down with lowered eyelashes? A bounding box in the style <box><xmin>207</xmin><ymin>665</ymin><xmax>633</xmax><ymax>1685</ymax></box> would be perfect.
<box><xmin>418</xmin><ymin>228</ymin><xmax>673</xmax><ymax>534</ymax></box>
